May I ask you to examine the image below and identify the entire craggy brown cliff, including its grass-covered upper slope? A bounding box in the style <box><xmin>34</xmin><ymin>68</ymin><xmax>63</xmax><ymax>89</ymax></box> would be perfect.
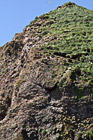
<box><xmin>0</xmin><ymin>2</ymin><xmax>93</xmax><ymax>140</ymax></box>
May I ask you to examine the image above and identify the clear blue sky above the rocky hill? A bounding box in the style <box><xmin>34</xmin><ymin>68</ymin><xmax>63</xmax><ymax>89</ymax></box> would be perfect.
<box><xmin>0</xmin><ymin>0</ymin><xmax>93</xmax><ymax>46</ymax></box>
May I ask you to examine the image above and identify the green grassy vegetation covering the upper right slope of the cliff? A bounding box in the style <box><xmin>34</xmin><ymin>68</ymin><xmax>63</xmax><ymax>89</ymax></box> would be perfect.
<box><xmin>31</xmin><ymin>2</ymin><xmax>93</xmax><ymax>97</ymax></box>
